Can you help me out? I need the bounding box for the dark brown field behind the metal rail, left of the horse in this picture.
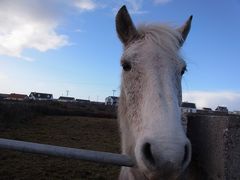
[0,116,120,180]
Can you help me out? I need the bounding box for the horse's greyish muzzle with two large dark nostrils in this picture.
[135,139,191,179]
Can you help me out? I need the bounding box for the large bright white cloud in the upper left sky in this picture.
[0,0,68,60]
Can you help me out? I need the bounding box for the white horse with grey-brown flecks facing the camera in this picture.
[116,6,192,180]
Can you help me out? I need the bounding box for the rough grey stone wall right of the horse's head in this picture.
[187,114,240,180]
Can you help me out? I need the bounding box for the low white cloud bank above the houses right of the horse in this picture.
[183,91,240,110]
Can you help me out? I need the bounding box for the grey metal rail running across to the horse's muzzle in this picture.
[0,138,134,167]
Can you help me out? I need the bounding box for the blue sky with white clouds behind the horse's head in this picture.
[0,0,240,110]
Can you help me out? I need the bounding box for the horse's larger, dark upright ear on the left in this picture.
[116,5,139,46]
